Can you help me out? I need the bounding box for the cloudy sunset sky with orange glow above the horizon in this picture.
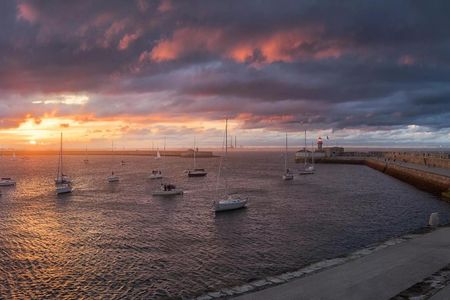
[0,0,450,149]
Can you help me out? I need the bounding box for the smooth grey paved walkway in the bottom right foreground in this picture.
[236,227,450,300]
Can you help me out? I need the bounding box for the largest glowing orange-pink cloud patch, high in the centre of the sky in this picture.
[146,28,342,63]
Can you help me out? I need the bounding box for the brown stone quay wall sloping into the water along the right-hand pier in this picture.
[317,158,450,197]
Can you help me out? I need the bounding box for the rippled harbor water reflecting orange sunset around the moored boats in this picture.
[0,152,450,299]
